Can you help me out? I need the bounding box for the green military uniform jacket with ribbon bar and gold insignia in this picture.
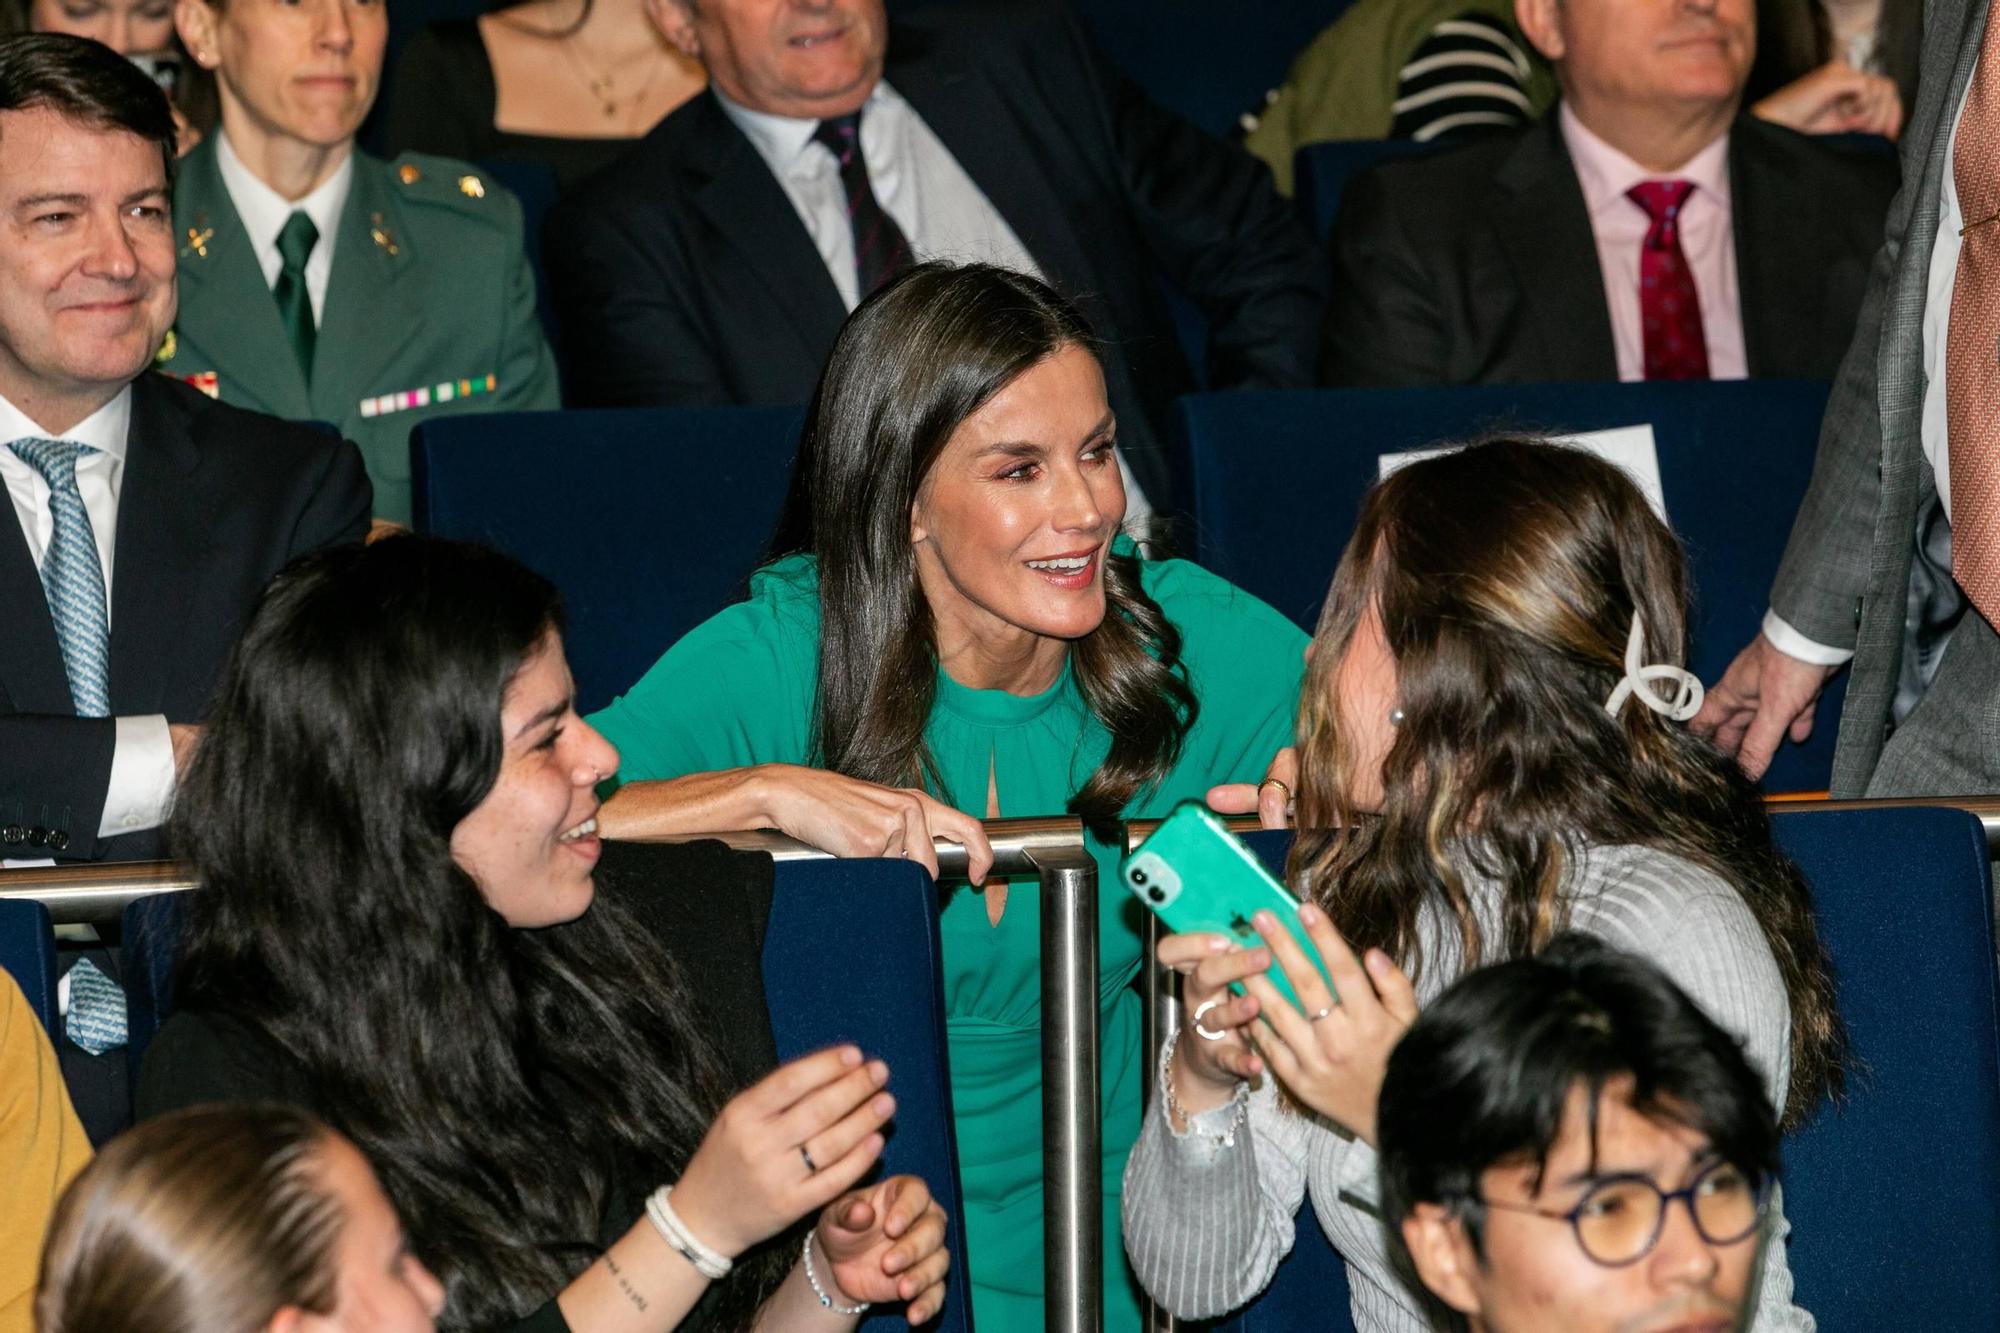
[158,138,560,522]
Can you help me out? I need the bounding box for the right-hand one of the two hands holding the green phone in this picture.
[1240,903,1416,1147]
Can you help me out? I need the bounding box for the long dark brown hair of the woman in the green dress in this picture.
[798,264,1198,831]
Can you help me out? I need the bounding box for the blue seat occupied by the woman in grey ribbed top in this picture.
[1222,809,2000,1333]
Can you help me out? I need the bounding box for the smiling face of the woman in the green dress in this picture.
[910,344,1126,656]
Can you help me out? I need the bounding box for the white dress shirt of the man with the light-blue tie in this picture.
[0,388,174,839]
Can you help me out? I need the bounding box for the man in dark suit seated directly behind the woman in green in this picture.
[544,0,1324,500]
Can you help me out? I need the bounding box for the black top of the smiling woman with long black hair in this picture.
[134,843,778,1333]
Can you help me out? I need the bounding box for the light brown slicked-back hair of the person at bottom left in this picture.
[34,1103,344,1333]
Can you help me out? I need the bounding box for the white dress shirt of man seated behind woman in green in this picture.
[714,80,1152,522]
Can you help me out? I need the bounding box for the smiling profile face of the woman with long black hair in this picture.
[452,634,618,927]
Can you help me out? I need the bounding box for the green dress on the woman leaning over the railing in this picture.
[590,556,1306,1333]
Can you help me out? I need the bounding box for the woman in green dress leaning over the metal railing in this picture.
[590,264,1306,1333]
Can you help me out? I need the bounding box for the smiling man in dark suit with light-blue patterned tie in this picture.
[0,36,370,861]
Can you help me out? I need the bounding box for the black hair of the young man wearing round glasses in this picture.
[1376,933,1778,1265]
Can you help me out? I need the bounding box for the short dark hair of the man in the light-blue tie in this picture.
[0,32,176,190]
